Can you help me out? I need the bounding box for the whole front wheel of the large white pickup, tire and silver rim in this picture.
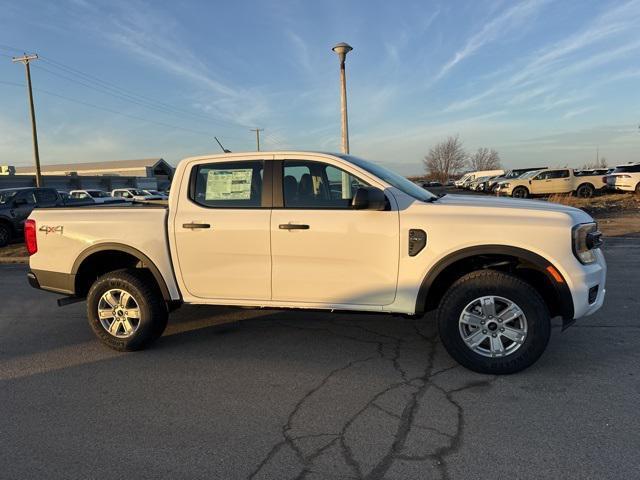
[437,270,551,374]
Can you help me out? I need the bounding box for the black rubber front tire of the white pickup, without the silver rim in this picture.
[437,270,551,375]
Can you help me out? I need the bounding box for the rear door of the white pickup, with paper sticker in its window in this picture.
[173,160,271,300]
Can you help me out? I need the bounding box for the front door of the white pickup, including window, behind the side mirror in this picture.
[271,160,399,305]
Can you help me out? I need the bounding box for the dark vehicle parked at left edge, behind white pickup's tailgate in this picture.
[0,187,63,247]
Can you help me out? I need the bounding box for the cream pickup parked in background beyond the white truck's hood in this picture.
[496,168,606,198]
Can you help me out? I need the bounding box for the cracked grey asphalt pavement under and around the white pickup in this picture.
[0,238,640,479]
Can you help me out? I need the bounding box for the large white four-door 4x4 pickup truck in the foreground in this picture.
[25,152,606,374]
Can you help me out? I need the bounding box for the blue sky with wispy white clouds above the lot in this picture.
[0,0,640,174]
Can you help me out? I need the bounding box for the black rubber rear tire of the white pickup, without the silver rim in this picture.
[87,269,168,352]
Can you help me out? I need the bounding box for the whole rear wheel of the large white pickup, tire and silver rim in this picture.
[87,269,168,352]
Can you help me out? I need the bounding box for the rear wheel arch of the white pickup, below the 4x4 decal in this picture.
[71,243,172,302]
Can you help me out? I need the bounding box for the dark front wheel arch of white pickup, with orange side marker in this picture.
[416,245,574,322]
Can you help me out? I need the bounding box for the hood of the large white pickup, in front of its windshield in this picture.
[437,195,593,223]
